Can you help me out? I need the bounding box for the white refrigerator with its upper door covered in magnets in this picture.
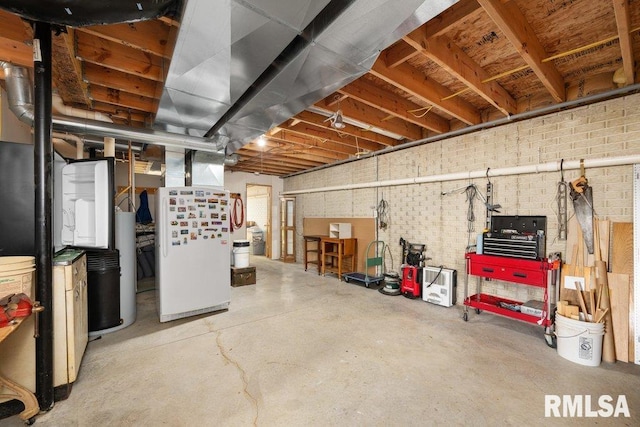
[155,187,231,322]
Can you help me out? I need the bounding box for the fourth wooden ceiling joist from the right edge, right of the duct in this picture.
[370,53,481,125]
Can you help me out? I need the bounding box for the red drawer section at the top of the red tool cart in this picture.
[467,254,549,287]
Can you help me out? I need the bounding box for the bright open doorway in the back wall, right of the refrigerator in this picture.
[247,184,272,258]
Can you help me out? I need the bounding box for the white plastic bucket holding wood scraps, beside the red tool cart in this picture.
[556,313,604,366]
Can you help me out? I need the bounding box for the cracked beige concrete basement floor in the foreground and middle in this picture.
[0,257,640,426]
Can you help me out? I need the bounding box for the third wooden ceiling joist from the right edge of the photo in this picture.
[403,27,517,116]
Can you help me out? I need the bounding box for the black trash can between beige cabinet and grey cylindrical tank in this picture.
[87,250,122,332]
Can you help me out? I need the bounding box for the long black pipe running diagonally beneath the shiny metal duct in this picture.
[204,0,356,138]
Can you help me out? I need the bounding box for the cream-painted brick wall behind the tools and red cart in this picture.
[284,95,640,304]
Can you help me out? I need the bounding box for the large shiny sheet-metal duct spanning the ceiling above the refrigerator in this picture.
[154,0,456,153]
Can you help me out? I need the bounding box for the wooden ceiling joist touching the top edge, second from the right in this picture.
[477,0,564,102]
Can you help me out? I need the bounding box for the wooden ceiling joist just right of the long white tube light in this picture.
[316,98,423,141]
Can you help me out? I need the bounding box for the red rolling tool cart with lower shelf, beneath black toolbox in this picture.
[462,253,560,347]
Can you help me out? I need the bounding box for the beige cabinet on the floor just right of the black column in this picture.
[53,250,89,391]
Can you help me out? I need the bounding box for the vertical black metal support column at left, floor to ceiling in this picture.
[33,22,53,411]
